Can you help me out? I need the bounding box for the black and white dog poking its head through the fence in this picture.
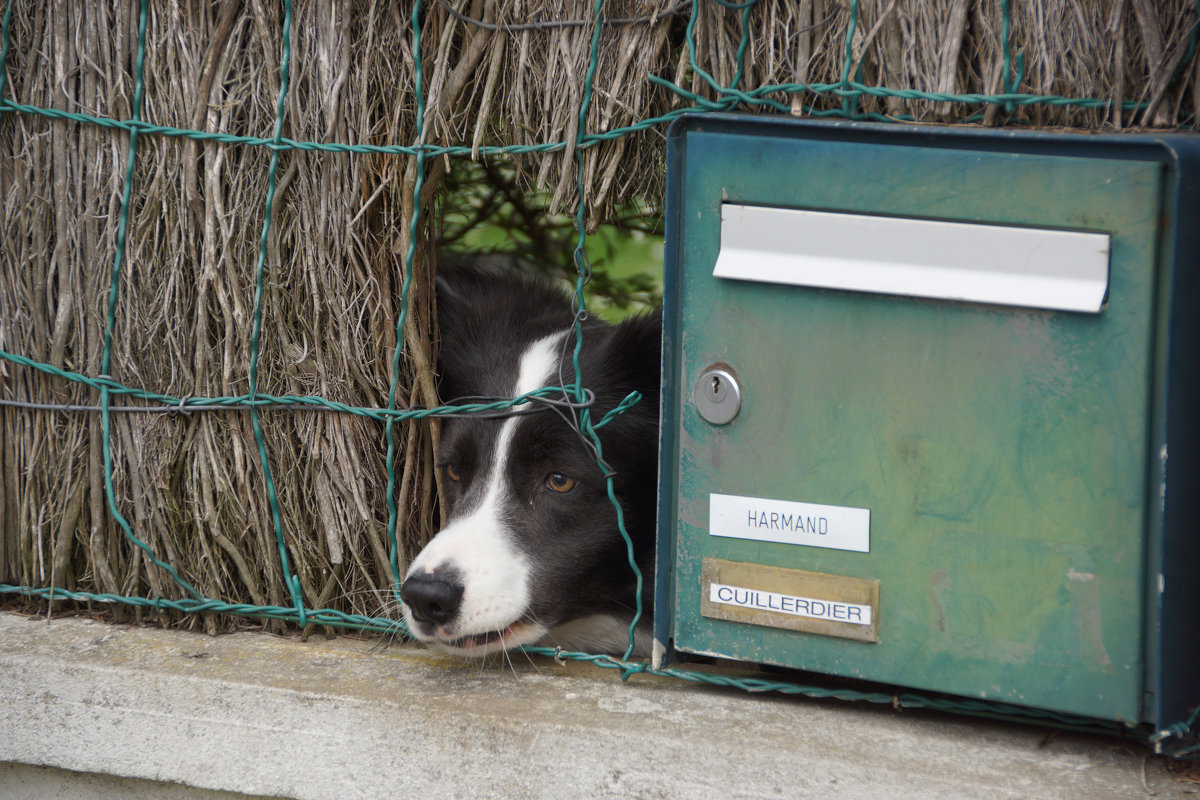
[401,270,662,656]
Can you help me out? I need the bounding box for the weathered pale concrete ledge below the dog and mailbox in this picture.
[0,614,1198,800]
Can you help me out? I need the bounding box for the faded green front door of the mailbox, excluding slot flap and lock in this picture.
[662,125,1162,722]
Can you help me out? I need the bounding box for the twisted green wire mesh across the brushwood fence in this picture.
[0,0,1200,756]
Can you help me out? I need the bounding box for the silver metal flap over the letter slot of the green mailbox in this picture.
[713,203,1111,314]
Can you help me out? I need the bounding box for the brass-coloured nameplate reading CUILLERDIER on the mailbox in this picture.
[700,558,880,642]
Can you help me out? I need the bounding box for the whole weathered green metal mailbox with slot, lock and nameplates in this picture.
[655,115,1200,726]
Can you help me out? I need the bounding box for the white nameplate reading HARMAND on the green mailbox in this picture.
[708,494,871,553]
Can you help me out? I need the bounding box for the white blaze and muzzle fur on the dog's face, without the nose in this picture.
[404,333,564,656]
